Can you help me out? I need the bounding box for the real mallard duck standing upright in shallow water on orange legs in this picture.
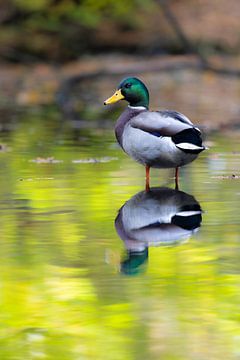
[104,77,205,190]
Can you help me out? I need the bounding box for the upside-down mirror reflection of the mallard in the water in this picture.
[115,187,202,275]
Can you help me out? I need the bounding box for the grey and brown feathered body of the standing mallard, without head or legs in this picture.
[115,107,204,168]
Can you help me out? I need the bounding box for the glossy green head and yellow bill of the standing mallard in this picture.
[104,77,149,109]
